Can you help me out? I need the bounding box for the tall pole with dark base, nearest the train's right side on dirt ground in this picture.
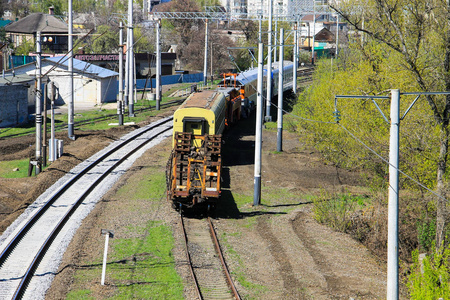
[253,42,264,206]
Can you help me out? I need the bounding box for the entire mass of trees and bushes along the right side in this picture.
[294,0,450,299]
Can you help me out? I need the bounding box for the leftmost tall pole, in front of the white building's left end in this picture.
[35,31,42,175]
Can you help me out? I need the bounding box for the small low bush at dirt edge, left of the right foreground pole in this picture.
[313,193,367,232]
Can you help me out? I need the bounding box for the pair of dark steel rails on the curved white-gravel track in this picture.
[0,117,173,299]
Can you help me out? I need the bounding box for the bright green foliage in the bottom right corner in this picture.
[408,247,450,300]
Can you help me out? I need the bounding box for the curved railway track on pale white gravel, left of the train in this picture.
[0,117,173,299]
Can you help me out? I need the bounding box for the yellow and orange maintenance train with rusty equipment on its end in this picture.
[166,62,293,209]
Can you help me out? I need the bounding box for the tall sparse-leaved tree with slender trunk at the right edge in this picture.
[333,0,450,249]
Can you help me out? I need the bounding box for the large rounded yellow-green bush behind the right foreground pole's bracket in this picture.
[293,43,439,188]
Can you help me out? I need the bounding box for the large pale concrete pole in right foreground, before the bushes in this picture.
[386,89,400,300]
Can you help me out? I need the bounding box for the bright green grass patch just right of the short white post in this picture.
[108,222,183,299]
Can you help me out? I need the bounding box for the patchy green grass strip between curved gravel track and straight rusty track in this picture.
[67,165,184,299]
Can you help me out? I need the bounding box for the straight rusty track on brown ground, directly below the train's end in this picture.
[180,215,241,300]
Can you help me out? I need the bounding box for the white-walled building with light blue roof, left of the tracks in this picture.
[6,56,119,105]
